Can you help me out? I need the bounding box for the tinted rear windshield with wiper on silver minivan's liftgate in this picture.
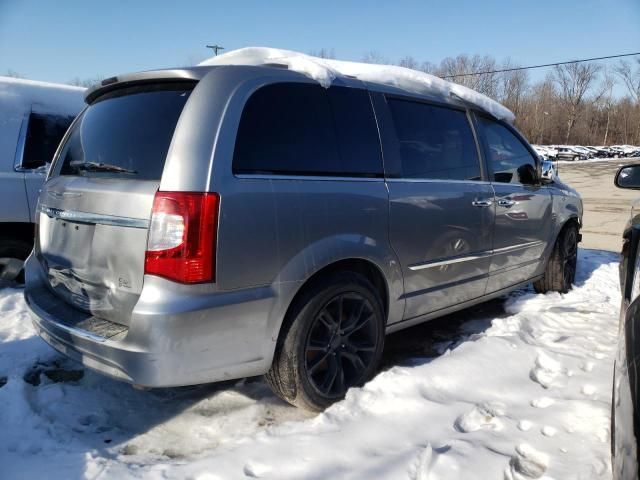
[59,82,194,180]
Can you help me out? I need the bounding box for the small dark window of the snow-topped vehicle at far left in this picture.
[22,113,74,168]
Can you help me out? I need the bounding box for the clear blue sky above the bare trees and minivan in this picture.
[0,0,640,93]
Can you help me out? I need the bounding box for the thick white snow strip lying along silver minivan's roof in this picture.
[199,47,515,122]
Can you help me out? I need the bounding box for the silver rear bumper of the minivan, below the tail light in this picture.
[24,256,279,387]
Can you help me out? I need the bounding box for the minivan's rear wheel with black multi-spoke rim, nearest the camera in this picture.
[265,272,385,411]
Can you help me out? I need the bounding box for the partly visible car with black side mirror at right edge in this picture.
[611,164,640,480]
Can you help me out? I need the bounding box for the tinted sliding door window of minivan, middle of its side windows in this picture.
[389,99,481,180]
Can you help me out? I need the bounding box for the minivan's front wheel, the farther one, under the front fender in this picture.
[533,223,578,293]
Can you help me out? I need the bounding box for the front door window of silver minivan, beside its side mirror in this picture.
[478,118,537,184]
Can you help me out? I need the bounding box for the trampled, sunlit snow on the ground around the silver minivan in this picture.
[0,250,619,480]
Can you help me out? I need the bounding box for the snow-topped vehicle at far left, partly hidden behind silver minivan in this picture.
[0,77,84,284]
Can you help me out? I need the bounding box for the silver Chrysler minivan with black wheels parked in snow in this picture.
[25,65,582,410]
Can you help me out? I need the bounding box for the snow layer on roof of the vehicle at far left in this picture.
[0,76,85,115]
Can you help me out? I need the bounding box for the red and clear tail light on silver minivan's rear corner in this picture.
[144,192,220,283]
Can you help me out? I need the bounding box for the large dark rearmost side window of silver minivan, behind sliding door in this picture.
[233,83,382,176]
